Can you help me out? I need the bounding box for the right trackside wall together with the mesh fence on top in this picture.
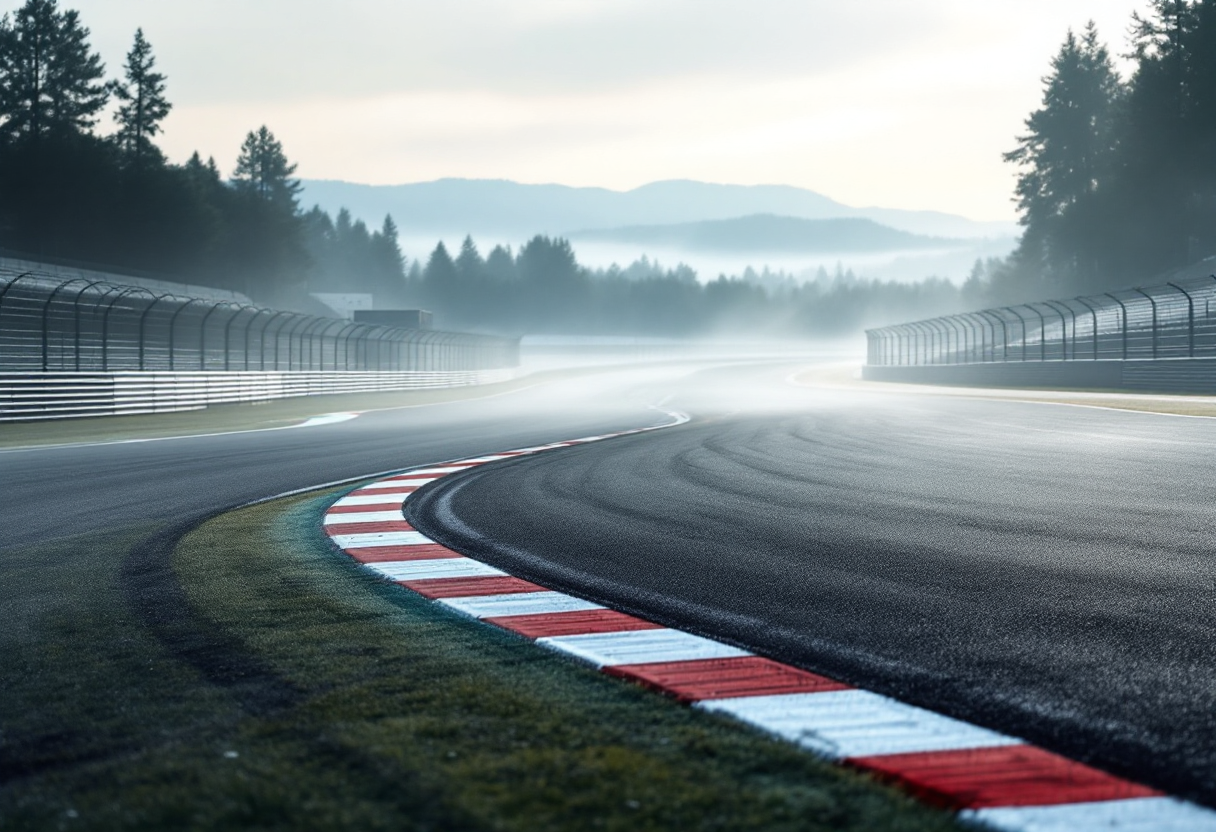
[863,275,1216,393]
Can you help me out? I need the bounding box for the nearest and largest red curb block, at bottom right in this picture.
[848,746,1162,809]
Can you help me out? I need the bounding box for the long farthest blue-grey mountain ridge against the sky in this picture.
[302,179,1018,240]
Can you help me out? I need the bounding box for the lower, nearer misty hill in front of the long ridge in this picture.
[570,214,958,254]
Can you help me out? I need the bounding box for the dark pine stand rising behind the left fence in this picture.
[0,0,405,307]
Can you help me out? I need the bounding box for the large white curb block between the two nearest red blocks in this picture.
[694,690,1021,759]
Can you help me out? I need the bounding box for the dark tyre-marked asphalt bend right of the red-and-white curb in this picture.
[409,367,1216,805]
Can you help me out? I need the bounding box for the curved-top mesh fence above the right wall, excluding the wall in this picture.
[866,275,1216,367]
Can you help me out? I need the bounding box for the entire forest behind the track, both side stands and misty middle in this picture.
[9,0,1216,337]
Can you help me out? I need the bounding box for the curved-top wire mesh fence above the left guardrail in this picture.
[0,269,519,373]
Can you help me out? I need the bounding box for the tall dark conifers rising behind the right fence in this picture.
[980,0,1216,303]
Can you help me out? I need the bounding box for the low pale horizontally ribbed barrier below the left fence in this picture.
[0,367,517,422]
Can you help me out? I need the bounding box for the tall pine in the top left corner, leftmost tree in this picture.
[0,0,108,141]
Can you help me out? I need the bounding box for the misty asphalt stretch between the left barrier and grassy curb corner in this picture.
[0,367,689,552]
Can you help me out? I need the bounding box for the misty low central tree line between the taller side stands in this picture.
[406,235,963,337]
